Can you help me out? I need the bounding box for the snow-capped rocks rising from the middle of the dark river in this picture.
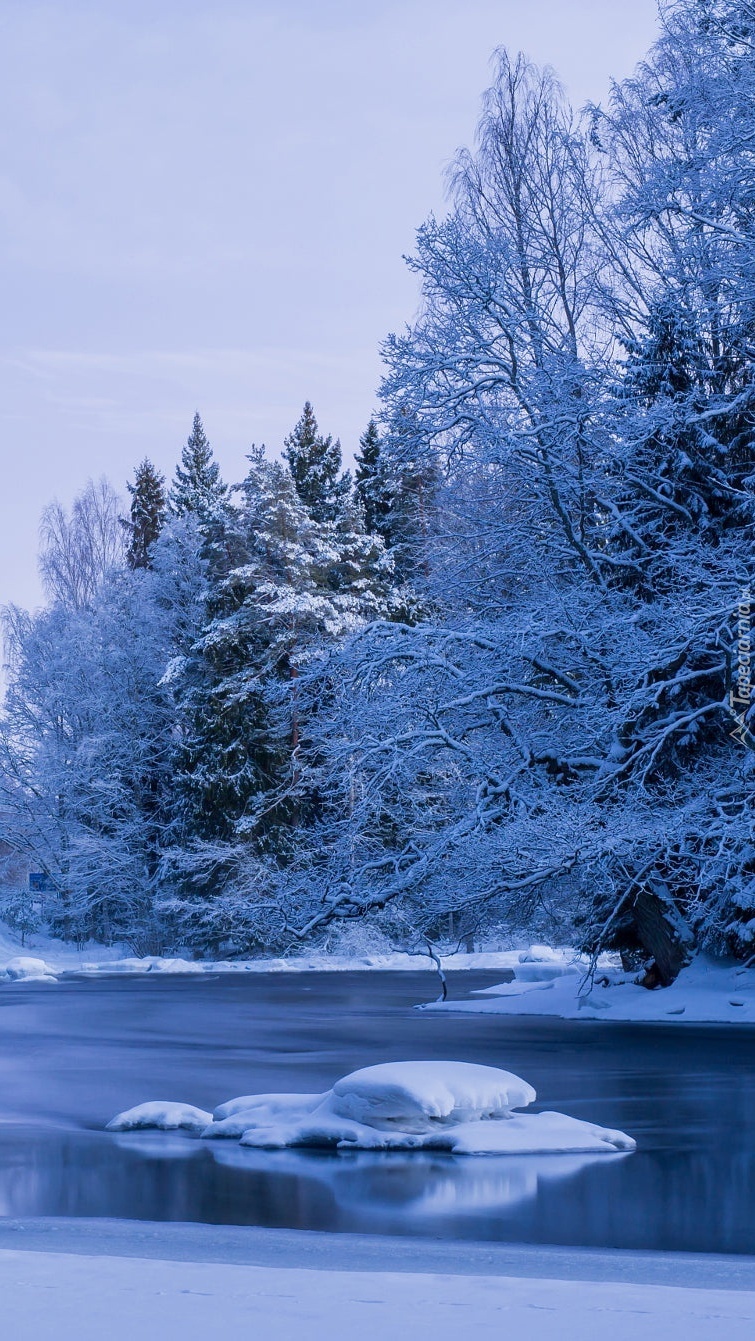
[107,1062,634,1155]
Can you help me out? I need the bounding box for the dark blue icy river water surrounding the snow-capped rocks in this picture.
[0,972,755,1252]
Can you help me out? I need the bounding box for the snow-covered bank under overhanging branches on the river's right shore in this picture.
[421,955,755,1025]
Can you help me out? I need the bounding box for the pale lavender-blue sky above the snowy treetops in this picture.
[0,0,656,603]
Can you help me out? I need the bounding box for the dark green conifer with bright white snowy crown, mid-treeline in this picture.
[172,449,390,852]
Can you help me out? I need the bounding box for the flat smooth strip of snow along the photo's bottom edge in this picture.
[0,1250,755,1341]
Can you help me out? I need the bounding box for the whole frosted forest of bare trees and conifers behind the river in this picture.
[0,0,755,986]
